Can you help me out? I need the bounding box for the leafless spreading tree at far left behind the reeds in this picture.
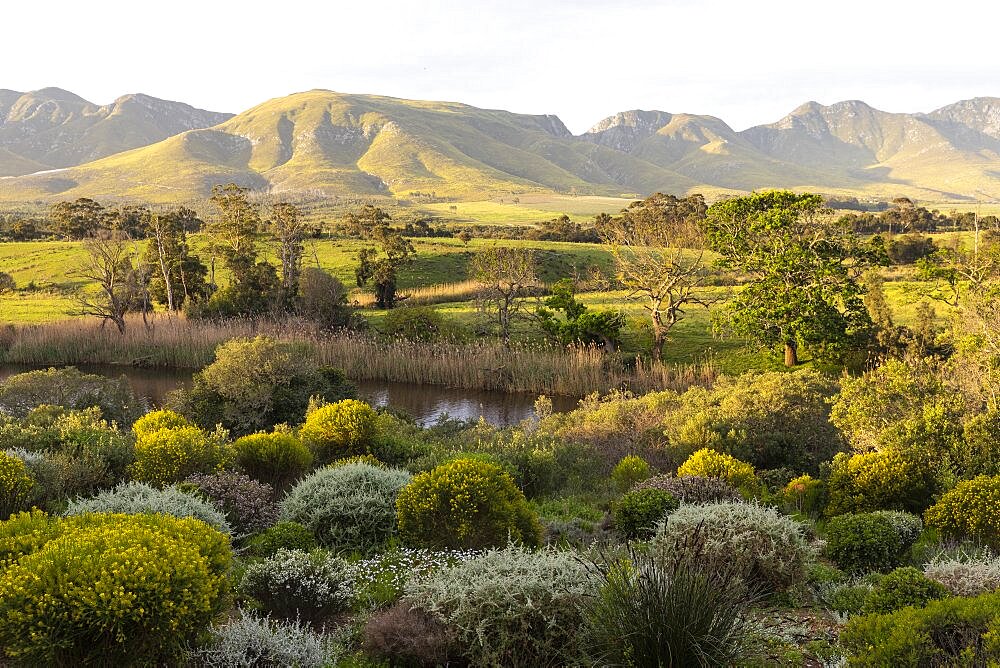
[73,231,142,334]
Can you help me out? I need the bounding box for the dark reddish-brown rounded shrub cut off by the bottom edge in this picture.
[362,603,461,666]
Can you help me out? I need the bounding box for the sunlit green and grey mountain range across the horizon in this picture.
[0,88,1000,202]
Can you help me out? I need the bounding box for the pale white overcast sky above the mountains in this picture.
[0,0,1000,133]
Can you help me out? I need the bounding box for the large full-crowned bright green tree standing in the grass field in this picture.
[705,191,884,366]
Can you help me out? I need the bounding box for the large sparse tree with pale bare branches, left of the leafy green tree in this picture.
[595,193,709,359]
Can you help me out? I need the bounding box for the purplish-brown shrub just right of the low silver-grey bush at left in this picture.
[185,471,278,535]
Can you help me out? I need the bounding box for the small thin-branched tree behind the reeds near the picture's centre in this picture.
[472,246,539,343]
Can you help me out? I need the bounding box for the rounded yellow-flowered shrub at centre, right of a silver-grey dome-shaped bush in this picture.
[396,459,541,549]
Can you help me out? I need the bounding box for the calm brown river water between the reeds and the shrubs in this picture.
[0,364,576,427]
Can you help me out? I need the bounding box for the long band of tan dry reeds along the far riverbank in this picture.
[0,317,717,396]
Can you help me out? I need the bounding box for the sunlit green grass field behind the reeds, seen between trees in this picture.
[0,228,968,373]
